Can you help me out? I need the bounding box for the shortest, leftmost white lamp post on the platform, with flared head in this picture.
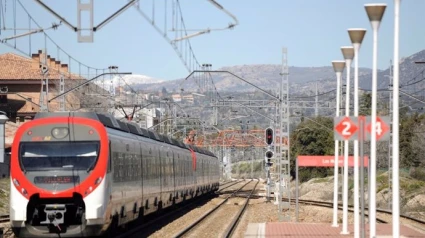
[332,60,345,227]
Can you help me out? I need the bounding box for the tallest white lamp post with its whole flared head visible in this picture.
[365,3,387,237]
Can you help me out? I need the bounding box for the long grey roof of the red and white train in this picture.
[34,112,215,157]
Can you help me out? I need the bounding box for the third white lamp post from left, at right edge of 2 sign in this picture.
[348,28,366,237]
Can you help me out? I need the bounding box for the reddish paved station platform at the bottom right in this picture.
[245,222,425,238]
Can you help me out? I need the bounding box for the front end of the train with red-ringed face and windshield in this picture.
[10,113,110,237]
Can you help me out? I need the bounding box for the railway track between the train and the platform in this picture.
[174,181,258,237]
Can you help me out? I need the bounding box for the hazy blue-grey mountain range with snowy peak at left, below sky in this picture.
[119,50,425,95]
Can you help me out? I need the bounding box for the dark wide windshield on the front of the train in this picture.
[19,141,100,172]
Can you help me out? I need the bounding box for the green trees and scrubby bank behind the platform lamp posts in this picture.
[290,93,425,212]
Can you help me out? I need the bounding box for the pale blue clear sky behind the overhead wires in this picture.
[0,0,425,80]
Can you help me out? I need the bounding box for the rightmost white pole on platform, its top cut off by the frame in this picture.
[392,0,401,237]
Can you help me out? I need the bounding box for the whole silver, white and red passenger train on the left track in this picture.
[10,112,219,237]
